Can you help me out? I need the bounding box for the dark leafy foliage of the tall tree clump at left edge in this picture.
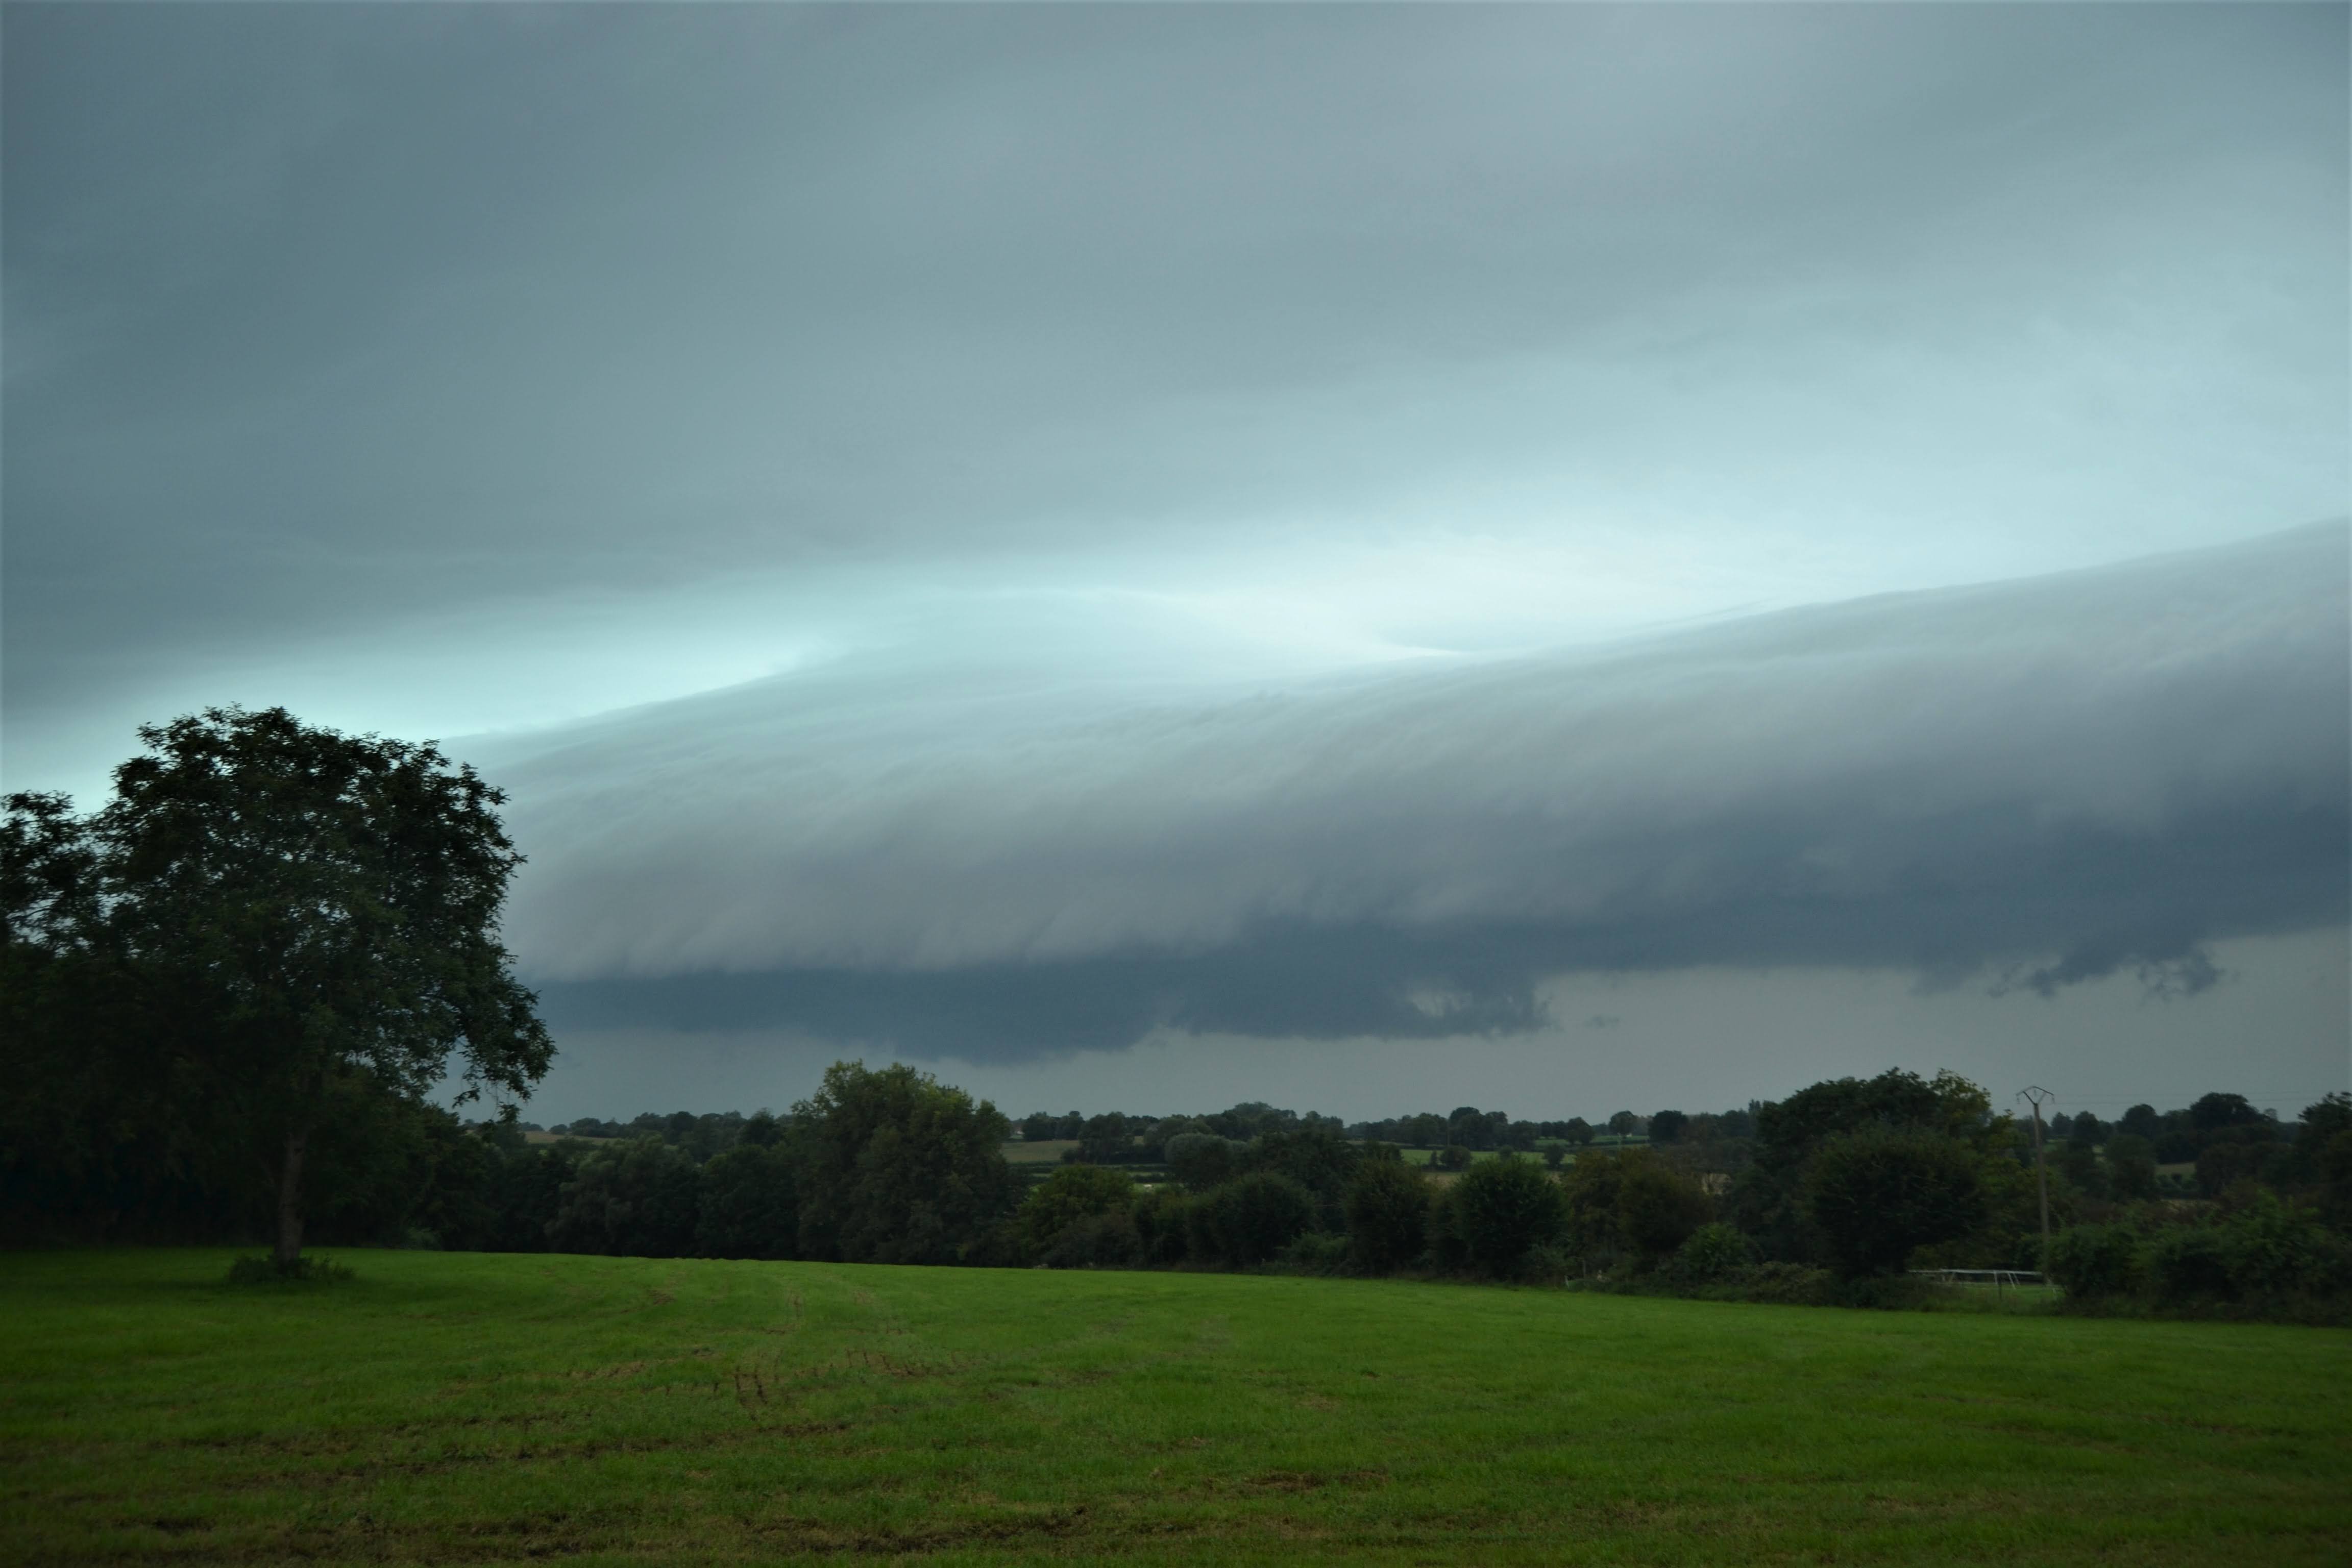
[0,707,553,1267]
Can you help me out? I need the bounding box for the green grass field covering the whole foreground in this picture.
[0,1251,2352,1565]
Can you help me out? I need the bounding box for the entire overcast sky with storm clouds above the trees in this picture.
[0,3,2352,1121]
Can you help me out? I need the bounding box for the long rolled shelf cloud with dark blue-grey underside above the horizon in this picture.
[515,524,2352,1058]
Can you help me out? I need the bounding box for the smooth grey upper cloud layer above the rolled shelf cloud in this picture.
[5,7,2345,724]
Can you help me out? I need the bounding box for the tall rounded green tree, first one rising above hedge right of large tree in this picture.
[793,1063,1018,1262]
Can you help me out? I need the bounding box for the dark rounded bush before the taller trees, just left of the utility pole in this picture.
[1806,1129,1985,1279]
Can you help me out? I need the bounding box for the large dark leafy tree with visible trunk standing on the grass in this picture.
[92,707,555,1269]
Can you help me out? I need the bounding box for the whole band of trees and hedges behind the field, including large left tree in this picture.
[0,710,2352,1305]
